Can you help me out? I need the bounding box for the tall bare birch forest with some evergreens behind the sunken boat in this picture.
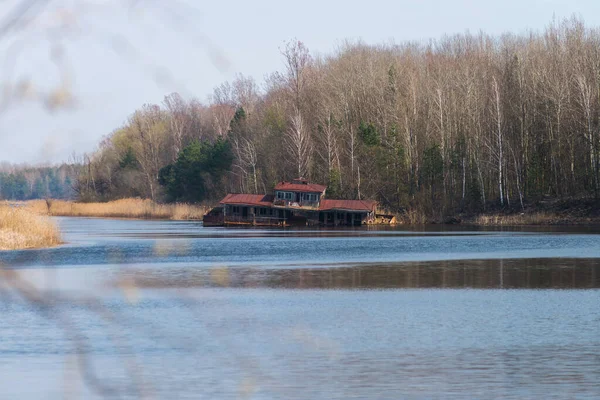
[79,19,600,216]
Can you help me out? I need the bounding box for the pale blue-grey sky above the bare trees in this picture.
[0,0,600,164]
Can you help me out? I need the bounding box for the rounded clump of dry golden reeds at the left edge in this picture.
[0,203,61,250]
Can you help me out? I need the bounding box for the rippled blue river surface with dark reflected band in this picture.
[0,218,600,400]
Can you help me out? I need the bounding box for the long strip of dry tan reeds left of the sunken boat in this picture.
[28,199,209,220]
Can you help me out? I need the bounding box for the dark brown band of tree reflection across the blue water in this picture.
[124,259,600,289]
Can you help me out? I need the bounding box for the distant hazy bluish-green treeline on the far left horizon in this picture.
[0,164,79,200]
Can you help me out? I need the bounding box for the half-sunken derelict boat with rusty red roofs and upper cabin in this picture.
[214,178,377,226]
